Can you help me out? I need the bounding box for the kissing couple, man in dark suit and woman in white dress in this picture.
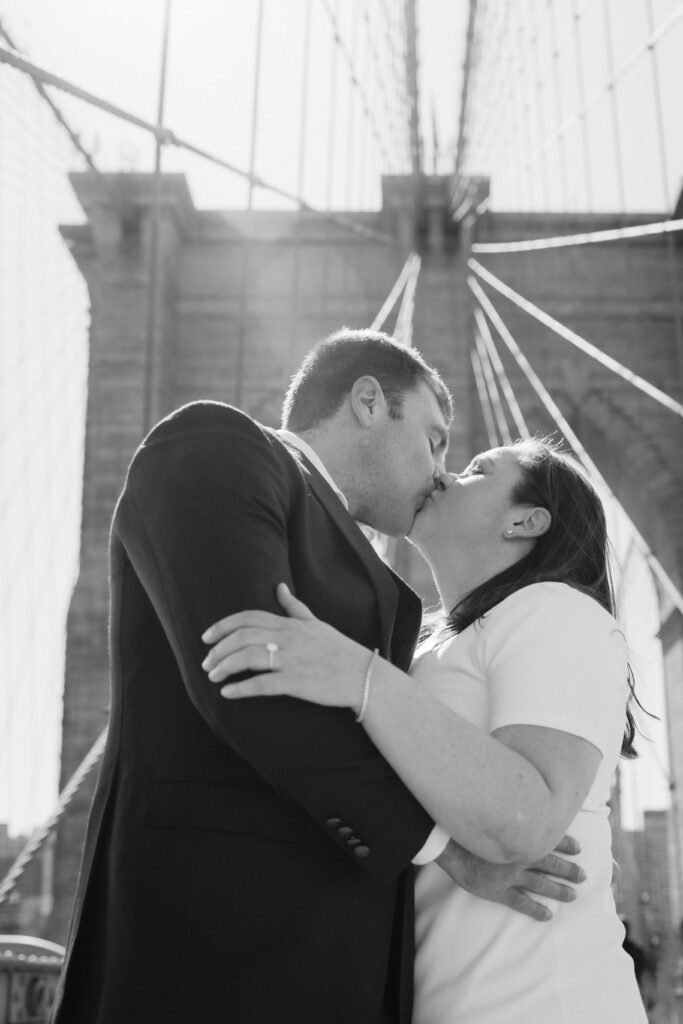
[52,330,646,1024]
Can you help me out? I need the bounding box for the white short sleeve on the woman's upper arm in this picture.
[477,583,628,757]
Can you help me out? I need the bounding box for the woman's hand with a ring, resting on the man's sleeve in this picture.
[202,583,370,711]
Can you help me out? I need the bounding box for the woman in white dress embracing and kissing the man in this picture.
[205,440,646,1024]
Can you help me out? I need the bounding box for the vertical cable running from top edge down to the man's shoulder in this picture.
[142,0,172,433]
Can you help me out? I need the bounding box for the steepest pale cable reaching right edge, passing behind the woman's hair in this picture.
[467,278,683,613]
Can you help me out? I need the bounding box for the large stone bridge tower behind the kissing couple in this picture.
[50,174,683,940]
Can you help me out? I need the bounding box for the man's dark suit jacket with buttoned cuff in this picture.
[53,403,432,1024]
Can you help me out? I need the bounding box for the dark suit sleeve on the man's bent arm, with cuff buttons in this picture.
[114,411,432,882]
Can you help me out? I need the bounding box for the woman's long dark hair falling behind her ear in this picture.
[437,438,637,758]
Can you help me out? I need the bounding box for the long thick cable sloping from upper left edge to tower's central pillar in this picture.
[0,46,402,249]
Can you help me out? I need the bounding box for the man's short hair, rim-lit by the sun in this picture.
[283,328,453,432]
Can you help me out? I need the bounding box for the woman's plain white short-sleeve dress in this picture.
[413,583,647,1024]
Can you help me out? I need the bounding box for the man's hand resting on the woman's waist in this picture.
[436,836,586,921]
